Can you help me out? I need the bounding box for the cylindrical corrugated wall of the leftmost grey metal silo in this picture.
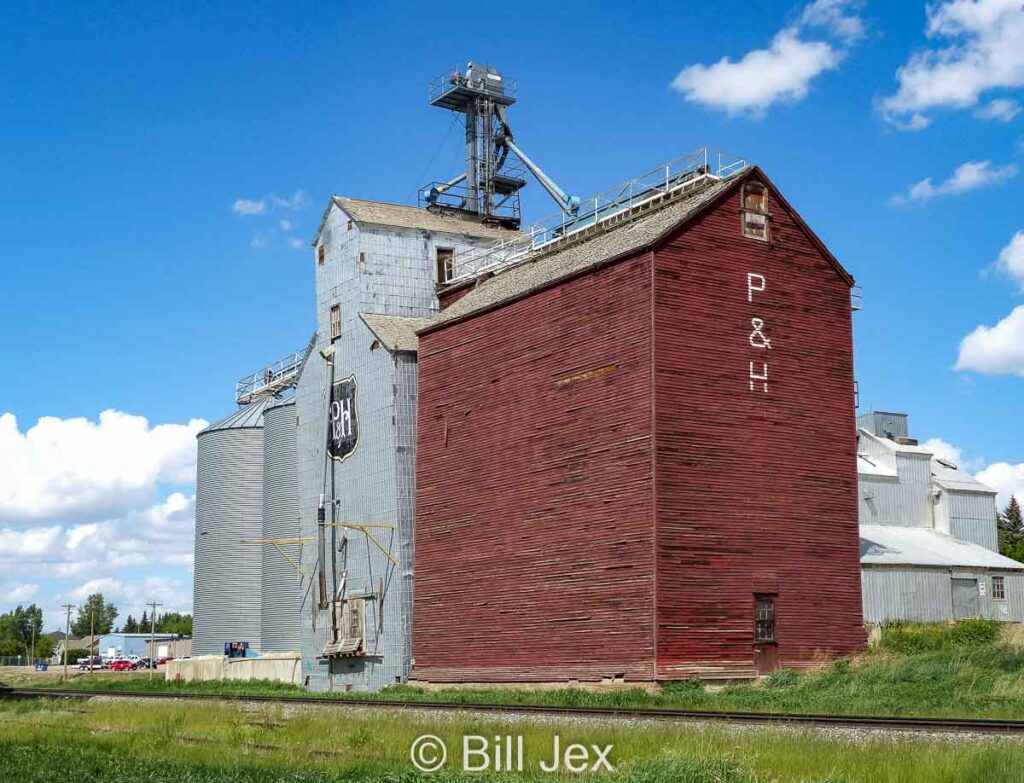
[193,427,263,655]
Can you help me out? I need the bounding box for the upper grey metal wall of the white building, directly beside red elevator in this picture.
[859,454,933,527]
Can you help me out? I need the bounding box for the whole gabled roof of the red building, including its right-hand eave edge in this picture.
[420,167,853,334]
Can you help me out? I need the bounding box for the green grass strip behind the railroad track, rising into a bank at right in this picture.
[19,620,1024,719]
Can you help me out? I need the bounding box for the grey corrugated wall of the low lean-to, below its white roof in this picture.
[861,566,1024,623]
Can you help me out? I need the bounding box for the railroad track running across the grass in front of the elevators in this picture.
[0,688,1024,735]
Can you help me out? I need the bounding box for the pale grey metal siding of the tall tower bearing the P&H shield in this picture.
[296,202,493,691]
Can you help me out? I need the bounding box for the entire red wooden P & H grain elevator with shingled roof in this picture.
[413,161,864,682]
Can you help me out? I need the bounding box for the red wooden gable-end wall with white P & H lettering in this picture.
[654,189,864,679]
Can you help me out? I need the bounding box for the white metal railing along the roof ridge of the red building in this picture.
[450,146,746,284]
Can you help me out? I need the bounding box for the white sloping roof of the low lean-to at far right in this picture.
[860,525,1024,571]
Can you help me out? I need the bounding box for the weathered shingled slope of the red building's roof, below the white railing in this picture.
[420,169,750,334]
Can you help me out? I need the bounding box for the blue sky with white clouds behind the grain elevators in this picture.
[0,0,1024,625]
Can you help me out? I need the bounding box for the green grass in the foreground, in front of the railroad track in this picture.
[0,699,1024,783]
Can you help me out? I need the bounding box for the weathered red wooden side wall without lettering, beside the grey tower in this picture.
[413,255,654,682]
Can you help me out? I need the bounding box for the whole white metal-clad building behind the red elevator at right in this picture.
[857,411,1024,622]
